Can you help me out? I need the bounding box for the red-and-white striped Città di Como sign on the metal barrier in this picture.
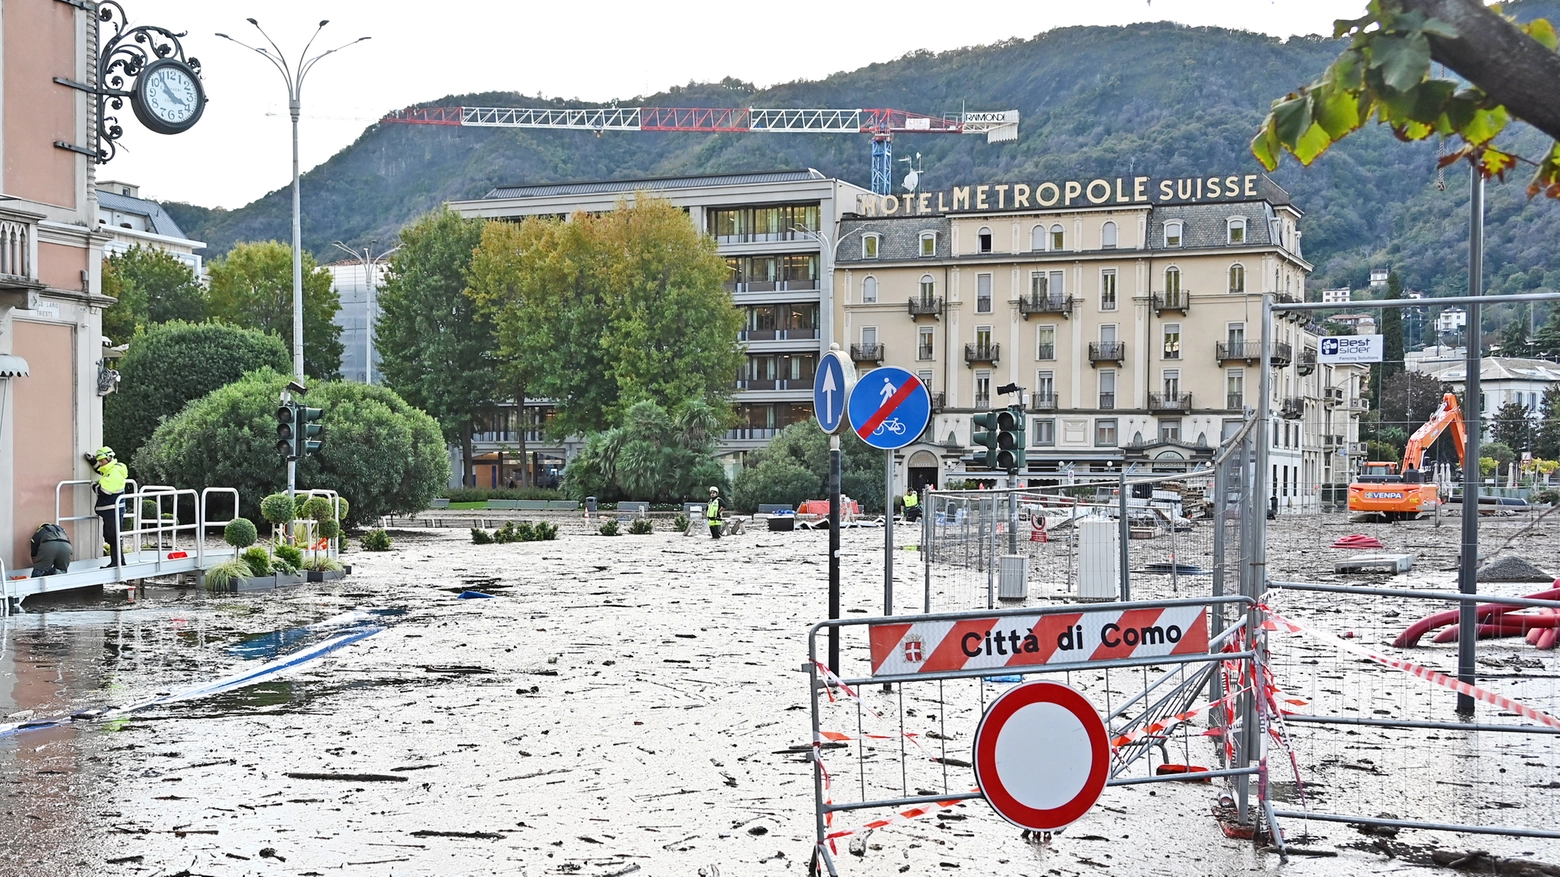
[869,605,1207,676]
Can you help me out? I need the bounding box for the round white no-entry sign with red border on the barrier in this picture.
[975,682,1111,832]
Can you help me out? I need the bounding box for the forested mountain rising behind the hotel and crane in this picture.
[168,0,1560,307]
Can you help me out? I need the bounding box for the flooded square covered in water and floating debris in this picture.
[0,517,1560,877]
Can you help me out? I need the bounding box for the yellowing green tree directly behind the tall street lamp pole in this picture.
[207,240,345,381]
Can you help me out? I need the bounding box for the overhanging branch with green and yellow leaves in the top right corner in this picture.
[1251,0,1560,198]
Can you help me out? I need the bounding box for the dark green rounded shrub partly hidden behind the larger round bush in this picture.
[103,321,292,460]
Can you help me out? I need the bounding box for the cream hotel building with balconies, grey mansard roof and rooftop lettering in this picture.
[833,175,1365,510]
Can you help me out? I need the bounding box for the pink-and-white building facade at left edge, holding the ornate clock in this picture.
[0,0,112,573]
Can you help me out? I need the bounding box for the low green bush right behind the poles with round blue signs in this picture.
[732,421,883,513]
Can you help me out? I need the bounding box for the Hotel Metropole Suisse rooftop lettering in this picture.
[856,173,1265,217]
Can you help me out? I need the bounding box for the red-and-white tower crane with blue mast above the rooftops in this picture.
[381,106,1019,195]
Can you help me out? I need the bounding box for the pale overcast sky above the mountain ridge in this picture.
[98,0,1365,208]
